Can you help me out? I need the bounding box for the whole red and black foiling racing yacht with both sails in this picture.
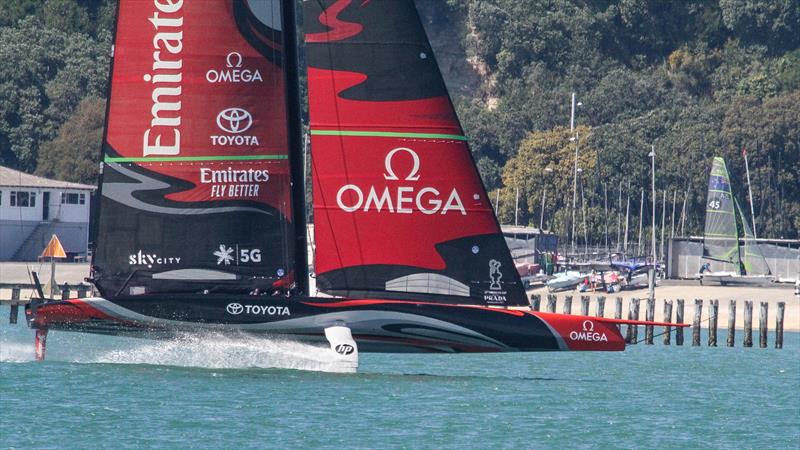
[26,0,676,370]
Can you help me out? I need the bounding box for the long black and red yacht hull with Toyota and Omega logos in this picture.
[26,294,625,353]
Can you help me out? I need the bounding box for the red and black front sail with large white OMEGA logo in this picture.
[305,0,527,305]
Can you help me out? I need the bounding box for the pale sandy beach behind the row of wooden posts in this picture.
[528,281,800,331]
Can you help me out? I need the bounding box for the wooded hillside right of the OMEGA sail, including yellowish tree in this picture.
[450,0,800,242]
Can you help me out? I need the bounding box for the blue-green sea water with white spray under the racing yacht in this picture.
[0,306,800,449]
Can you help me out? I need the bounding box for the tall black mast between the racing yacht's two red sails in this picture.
[283,1,308,295]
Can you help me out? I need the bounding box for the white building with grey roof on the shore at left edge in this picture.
[0,166,95,261]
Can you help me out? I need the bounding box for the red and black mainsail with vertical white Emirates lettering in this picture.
[92,0,296,298]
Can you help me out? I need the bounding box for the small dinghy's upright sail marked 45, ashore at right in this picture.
[703,157,741,272]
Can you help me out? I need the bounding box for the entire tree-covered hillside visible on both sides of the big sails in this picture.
[0,0,800,242]
